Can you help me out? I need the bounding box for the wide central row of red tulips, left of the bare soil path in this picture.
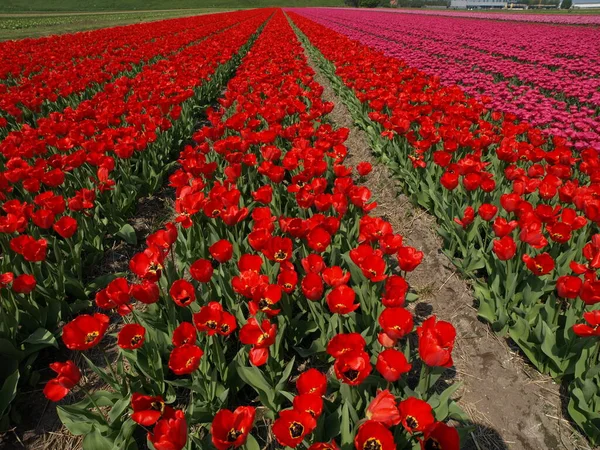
[44,11,464,450]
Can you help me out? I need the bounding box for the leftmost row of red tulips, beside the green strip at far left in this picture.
[0,14,248,135]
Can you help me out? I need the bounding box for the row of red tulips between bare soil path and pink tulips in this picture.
[292,9,600,441]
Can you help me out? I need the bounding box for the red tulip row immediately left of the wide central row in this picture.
[0,11,270,427]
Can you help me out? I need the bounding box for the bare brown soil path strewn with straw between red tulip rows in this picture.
[302,37,589,450]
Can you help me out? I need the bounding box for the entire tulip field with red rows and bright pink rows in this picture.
[0,8,600,450]
